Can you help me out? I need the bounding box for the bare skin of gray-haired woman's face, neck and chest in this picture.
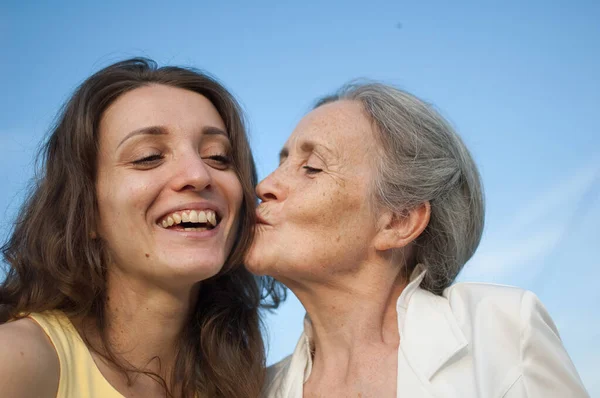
[246,101,408,398]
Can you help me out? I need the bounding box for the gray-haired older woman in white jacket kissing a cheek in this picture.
[247,84,587,398]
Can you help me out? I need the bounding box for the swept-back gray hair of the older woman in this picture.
[315,82,484,294]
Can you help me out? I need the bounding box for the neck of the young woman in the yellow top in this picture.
[86,271,198,381]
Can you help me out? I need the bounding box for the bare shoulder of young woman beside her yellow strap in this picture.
[0,318,60,397]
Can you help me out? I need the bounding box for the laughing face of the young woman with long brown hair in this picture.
[96,84,243,285]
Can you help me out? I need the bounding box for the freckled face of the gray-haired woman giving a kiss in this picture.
[246,101,377,282]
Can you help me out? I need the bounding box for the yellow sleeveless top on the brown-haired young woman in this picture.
[29,311,124,398]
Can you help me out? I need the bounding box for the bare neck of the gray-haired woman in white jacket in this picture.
[290,262,407,371]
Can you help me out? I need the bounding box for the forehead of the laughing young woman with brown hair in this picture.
[100,84,225,139]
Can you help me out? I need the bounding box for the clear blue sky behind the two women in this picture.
[0,0,600,396]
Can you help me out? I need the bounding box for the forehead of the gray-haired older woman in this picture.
[285,100,375,157]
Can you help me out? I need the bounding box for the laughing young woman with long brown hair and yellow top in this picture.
[0,59,276,398]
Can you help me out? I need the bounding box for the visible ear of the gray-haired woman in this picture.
[374,202,431,251]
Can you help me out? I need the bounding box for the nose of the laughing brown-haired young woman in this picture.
[172,153,212,191]
